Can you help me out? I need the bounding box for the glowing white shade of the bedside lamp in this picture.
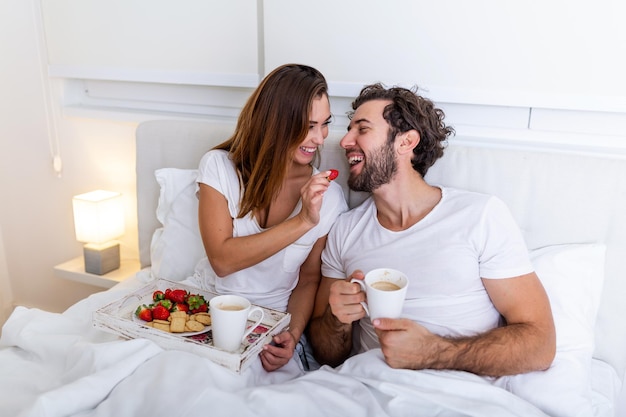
[72,190,124,244]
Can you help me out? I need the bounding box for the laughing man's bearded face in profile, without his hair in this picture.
[341,100,397,192]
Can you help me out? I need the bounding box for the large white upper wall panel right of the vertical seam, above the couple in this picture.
[265,0,626,111]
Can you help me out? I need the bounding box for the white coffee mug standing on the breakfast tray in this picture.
[209,295,265,352]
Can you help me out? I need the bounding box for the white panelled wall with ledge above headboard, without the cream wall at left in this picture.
[42,0,626,153]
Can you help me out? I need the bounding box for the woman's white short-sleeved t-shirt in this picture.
[191,150,348,311]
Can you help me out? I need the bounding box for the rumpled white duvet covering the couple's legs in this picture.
[0,276,546,417]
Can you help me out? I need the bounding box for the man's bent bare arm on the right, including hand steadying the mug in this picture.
[373,273,556,376]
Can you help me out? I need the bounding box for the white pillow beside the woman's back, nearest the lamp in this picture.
[150,168,205,281]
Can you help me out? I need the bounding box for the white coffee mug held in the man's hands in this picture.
[350,268,409,320]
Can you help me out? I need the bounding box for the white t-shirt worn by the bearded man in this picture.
[322,187,533,351]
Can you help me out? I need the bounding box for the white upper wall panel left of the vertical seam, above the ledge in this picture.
[42,0,258,86]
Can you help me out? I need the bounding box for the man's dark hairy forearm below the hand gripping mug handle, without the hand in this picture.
[309,306,352,367]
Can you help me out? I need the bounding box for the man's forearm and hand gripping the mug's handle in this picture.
[308,277,365,366]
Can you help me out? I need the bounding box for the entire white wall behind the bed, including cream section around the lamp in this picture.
[0,0,626,328]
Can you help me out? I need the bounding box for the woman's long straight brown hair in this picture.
[214,64,328,218]
